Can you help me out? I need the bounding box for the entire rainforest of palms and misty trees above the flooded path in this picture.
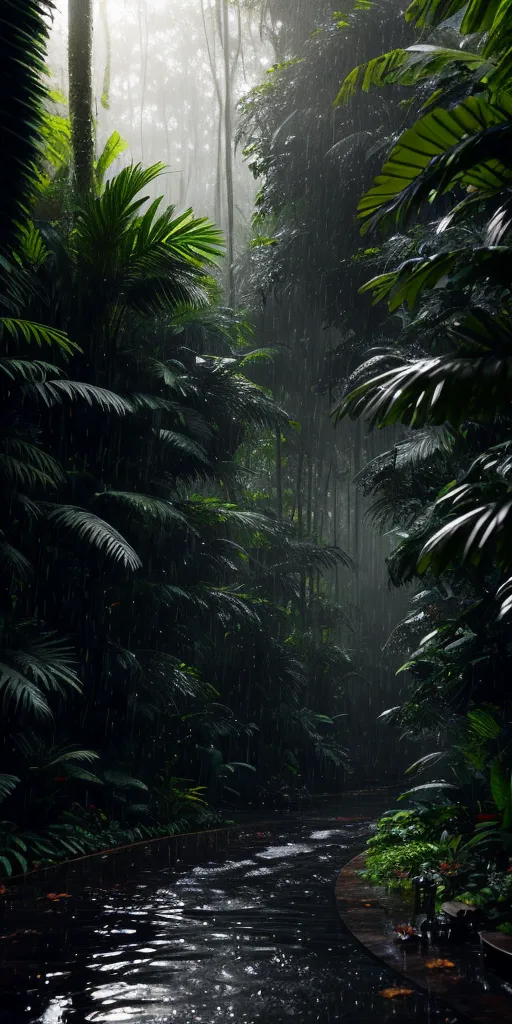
[4,0,512,1007]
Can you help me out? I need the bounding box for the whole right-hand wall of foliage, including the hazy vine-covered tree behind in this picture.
[240,0,512,932]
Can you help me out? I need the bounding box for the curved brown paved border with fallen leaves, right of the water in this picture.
[336,854,512,1024]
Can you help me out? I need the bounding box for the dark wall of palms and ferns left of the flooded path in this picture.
[0,0,350,873]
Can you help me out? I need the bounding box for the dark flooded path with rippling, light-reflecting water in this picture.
[0,801,461,1024]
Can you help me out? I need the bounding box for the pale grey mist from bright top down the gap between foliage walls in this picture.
[44,0,408,771]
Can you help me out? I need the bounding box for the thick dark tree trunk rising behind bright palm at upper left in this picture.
[68,0,94,200]
